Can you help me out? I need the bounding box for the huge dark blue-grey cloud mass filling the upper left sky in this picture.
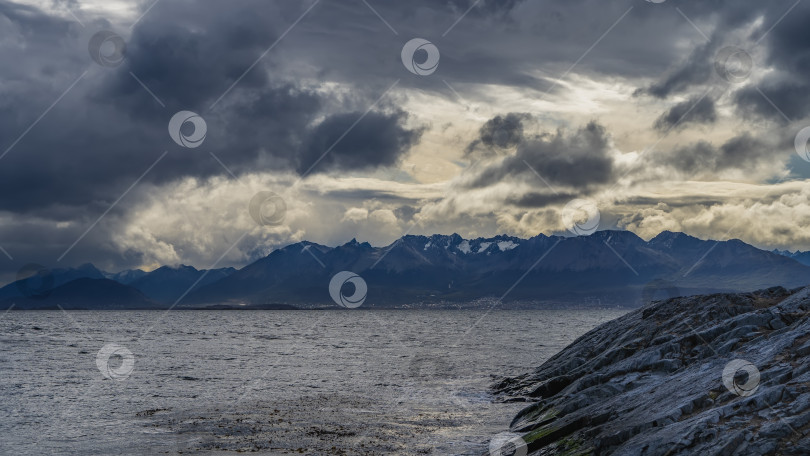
[0,1,430,216]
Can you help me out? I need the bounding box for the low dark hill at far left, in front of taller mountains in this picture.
[3,278,159,310]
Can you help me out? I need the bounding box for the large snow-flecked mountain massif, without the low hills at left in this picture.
[186,231,810,306]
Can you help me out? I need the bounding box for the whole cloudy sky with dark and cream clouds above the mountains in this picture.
[0,0,810,278]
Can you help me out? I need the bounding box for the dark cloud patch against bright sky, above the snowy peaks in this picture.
[468,122,613,189]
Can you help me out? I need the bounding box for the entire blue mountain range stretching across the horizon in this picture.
[0,231,810,309]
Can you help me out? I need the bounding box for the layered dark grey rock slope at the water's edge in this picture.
[489,287,810,456]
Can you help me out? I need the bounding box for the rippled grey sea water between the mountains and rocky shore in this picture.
[0,310,624,455]
